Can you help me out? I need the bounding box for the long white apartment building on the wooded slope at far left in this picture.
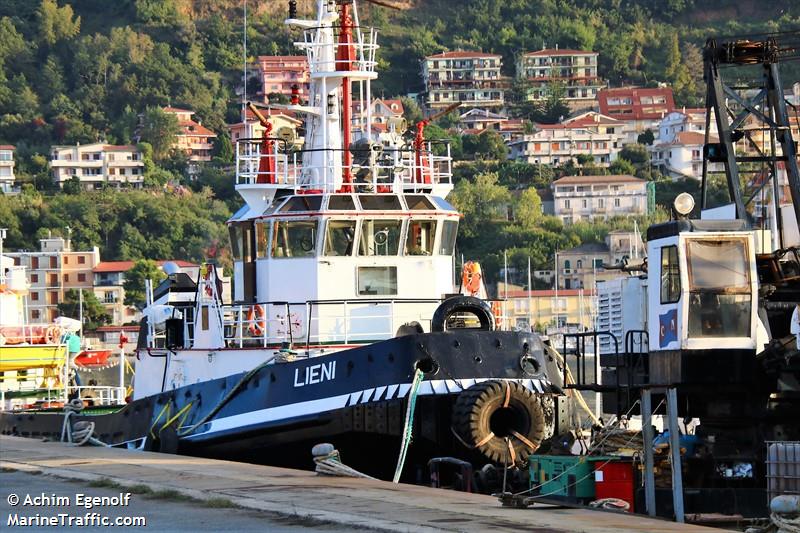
[50,143,144,189]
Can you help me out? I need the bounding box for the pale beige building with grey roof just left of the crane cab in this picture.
[556,230,647,289]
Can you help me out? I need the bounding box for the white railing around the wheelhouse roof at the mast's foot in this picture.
[236,139,453,194]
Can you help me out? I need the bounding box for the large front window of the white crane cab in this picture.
[686,239,752,337]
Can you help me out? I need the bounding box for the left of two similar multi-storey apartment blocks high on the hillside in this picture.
[422,51,510,109]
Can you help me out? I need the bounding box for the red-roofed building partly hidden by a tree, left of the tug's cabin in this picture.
[92,260,200,326]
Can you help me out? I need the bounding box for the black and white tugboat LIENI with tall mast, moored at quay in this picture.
[0,0,562,481]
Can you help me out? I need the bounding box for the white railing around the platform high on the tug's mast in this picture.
[294,26,378,78]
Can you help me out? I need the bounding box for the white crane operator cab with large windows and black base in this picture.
[647,203,767,385]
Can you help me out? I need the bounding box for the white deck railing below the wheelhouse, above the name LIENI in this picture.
[216,299,441,349]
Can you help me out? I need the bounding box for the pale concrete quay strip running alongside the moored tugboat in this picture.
[0,436,719,533]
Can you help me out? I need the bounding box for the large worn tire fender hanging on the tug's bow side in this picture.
[453,380,545,465]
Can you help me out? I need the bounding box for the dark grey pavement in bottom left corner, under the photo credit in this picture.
[0,470,352,533]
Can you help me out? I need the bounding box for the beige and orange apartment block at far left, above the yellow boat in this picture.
[5,237,100,324]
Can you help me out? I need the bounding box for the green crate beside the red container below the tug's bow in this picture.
[528,455,610,499]
